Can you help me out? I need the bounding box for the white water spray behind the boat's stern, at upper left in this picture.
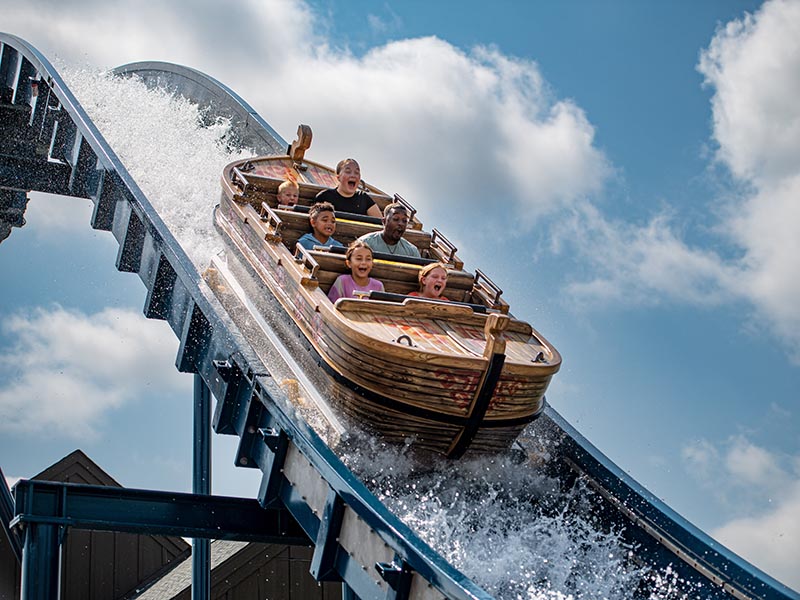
[61,66,252,270]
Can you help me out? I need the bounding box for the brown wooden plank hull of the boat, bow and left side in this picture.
[215,159,560,456]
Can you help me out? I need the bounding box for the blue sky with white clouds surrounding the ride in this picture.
[0,0,800,589]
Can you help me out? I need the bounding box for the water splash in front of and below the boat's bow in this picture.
[343,424,664,599]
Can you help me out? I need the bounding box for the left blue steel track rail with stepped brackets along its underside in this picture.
[0,33,491,600]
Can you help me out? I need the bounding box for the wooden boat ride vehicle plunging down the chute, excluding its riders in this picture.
[215,126,561,458]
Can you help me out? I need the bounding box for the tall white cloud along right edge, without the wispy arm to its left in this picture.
[699,0,800,361]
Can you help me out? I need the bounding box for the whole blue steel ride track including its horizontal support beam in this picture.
[0,33,800,600]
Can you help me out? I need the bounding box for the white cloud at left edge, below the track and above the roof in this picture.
[0,306,190,440]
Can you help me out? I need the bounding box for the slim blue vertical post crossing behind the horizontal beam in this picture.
[192,374,211,600]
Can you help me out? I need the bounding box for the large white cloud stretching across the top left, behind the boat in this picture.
[4,0,610,237]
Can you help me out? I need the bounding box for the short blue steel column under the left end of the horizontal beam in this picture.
[20,523,61,600]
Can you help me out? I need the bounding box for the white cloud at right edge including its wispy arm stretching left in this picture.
[554,0,800,362]
